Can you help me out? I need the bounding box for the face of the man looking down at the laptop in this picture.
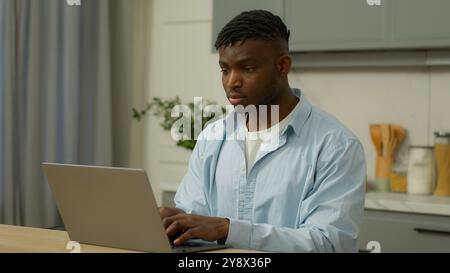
[219,40,281,107]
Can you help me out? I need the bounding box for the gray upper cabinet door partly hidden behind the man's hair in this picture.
[212,0,284,51]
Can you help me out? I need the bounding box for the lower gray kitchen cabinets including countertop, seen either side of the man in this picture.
[162,188,450,253]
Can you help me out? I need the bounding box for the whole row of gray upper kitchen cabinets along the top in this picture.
[212,0,450,53]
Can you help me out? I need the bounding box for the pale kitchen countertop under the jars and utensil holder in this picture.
[365,192,450,216]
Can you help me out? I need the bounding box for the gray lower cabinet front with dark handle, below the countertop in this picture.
[358,209,450,252]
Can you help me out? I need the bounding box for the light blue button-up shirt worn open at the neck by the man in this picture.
[175,89,366,252]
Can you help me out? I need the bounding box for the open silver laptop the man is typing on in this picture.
[42,163,226,253]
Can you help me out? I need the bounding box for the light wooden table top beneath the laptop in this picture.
[0,225,256,253]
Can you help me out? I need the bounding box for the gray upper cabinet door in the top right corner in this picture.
[390,0,450,48]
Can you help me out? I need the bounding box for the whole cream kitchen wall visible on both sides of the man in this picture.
[145,0,450,204]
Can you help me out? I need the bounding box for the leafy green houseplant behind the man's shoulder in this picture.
[133,96,226,150]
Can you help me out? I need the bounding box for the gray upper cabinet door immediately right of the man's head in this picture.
[285,0,390,51]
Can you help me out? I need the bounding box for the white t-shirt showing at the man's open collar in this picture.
[245,102,300,174]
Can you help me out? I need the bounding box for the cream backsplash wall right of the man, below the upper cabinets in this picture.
[290,67,450,179]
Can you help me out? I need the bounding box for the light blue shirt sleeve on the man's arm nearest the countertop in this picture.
[226,139,366,252]
